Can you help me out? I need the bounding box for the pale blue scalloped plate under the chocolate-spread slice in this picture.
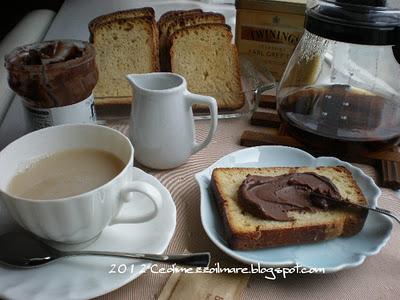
[196,146,392,273]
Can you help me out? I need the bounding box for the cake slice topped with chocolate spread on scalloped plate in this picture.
[211,167,367,250]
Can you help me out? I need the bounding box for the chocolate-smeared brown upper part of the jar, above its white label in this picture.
[5,40,98,108]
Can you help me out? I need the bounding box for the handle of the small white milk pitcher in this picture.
[185,91,218,154]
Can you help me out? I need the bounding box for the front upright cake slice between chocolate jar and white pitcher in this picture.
[92,16,159,105]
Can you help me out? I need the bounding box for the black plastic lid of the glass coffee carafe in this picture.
[305,0,400,45]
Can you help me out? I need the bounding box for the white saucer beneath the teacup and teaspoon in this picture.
[0,168,176,300]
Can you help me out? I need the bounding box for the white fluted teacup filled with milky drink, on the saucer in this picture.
[0,124,163,244]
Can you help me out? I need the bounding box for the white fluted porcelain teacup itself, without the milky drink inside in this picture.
[0,124,162,244]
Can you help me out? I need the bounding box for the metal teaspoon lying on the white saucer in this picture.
[0,232,210,268]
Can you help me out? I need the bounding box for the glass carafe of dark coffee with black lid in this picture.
[277,0,400,153]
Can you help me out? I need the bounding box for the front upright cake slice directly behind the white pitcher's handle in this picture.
[169,24,244,111]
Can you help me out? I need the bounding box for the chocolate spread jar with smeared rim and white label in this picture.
[5,40,98,129]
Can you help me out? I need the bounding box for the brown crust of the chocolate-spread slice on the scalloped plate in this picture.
[210,167,367,250]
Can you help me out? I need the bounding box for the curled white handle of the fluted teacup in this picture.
[110,181,162,225]
